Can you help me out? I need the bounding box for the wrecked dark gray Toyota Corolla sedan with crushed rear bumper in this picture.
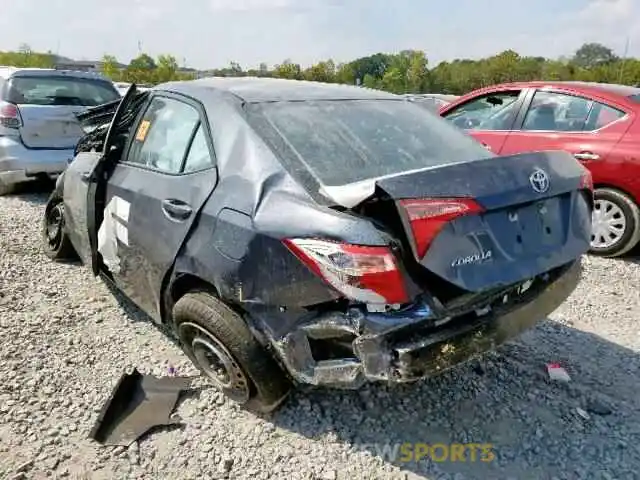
[42,78,593,411]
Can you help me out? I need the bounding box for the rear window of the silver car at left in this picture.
[2,75,120,107]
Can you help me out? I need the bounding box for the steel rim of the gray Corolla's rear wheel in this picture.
[179,322,251,403]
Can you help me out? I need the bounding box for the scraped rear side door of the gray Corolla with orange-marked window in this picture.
[98,93,218,321]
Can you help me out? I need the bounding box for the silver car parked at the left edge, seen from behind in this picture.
[0,67,120,195]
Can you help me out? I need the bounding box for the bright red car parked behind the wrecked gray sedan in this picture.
[439,82,640,257]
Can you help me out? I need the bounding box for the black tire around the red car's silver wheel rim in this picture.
[589,188,640,258]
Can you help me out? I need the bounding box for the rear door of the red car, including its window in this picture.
[502,89,631,166]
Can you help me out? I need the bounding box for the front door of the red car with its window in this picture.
[441,89,527,154]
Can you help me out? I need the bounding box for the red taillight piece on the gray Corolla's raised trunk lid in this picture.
[400,198,484,258]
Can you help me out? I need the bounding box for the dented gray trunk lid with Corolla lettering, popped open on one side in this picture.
[328,151,591,292]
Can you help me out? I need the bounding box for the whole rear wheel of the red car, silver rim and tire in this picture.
[590,188,640,257]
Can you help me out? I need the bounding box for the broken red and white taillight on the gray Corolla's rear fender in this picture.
[284,238,408,304]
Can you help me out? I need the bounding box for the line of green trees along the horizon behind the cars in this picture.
[0,43,640,94]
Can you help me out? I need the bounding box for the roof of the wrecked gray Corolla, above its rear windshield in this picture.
[155,77,402,103]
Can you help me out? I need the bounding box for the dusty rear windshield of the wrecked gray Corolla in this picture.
[248,100,492,186]
